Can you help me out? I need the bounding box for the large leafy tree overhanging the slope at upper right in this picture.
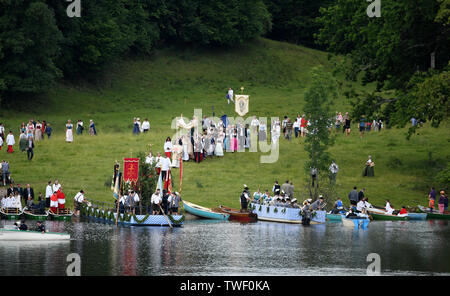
[317,0,450,133]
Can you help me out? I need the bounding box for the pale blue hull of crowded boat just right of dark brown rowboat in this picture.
[251,203,326,224]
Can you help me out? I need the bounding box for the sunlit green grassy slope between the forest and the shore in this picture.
[0,39,449,207]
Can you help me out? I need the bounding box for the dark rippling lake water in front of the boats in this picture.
[0,220,450,276]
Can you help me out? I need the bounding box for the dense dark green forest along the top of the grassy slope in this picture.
[0,0,450,134]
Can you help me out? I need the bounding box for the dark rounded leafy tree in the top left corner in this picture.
[0,0,61,94]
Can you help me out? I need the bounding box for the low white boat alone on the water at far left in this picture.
[0,228,70,241]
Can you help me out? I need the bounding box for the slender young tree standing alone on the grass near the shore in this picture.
[304,67,337,198]
